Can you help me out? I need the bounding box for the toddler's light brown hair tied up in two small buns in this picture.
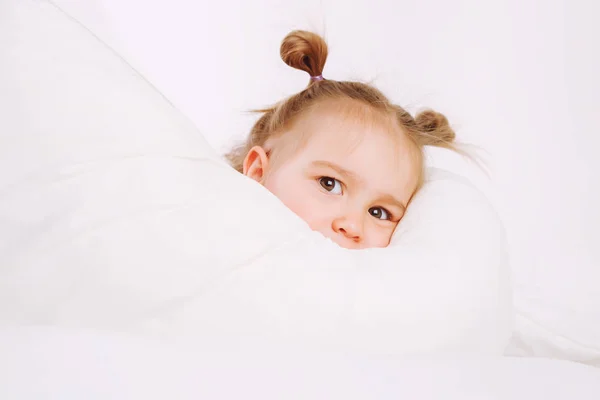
[225,31,460,182]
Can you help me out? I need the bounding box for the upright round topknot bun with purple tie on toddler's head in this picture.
[280,31,327,77]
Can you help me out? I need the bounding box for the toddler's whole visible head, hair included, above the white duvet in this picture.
[227,31,455,249]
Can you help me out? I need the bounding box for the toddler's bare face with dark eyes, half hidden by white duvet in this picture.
[246,101,420,249]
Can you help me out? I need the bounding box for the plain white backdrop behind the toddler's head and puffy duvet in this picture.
[55,0,600,304]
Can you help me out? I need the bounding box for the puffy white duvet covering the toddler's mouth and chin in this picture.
[0,0,511,354]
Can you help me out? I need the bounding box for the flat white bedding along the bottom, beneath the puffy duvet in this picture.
[0,328,600,400]
